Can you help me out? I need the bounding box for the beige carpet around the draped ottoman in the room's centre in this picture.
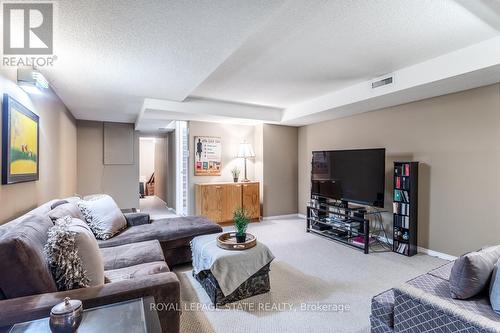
[175,219,445,333]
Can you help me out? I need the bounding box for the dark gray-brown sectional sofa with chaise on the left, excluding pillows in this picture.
[0,200,222,332]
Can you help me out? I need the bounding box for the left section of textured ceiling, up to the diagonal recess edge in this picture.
[44,0,282,121]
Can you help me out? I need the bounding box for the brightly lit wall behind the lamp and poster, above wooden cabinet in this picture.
[189,121,255,214]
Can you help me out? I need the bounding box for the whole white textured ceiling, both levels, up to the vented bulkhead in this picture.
[42,0,500,128]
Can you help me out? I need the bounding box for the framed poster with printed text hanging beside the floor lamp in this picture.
[194,136,222,176]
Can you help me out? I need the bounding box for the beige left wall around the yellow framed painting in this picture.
[0,70,76,223]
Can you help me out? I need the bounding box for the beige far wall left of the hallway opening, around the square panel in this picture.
[77,120,139,208]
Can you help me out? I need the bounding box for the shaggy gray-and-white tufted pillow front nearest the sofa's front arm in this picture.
[44,216,90,291]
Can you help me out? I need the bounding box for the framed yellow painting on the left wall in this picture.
[2,94,40,185]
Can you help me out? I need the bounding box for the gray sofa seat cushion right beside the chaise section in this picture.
[101,240,165,270]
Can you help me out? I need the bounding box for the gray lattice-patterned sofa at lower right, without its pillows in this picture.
[370,262,500,333]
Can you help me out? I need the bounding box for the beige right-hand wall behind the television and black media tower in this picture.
[299,84,500,255]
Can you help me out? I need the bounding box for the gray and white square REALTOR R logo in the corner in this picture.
[3,2,54,55]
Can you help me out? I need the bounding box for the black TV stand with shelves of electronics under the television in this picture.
[306,195,370,254]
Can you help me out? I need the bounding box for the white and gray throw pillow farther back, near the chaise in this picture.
[78,195,127,240]
